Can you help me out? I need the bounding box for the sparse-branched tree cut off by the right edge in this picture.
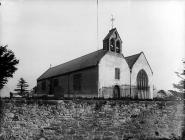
[173,60,185,93]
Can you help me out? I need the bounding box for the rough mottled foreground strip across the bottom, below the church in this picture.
[0,100,184,140]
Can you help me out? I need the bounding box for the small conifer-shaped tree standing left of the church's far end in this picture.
[15,78,29,96]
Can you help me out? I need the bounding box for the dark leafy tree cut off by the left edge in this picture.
[0,45,19,89]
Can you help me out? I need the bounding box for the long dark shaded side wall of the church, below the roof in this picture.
[37,67,98,98]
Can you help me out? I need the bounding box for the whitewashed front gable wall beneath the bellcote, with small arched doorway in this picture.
[98,52,130,98]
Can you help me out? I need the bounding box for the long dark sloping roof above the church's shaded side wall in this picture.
[37,49,107,81]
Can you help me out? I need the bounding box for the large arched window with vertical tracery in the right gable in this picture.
[137,70,148,90]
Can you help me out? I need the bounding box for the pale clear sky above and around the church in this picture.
[0,0,185,94]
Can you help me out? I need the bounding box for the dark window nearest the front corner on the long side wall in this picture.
[73,74,82,90]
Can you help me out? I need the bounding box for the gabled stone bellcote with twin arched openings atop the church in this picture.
[103,28,122,53]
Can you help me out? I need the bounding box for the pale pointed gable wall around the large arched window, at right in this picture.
[131,53,153,99]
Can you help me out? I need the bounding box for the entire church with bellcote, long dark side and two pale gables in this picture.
[37,28,153,99]
